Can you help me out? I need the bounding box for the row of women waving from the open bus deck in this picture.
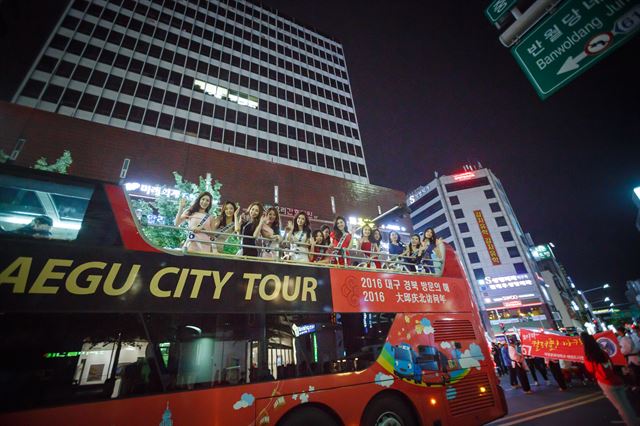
[174,192,443,273]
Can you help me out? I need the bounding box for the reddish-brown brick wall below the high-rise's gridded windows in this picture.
[0,102,411,229]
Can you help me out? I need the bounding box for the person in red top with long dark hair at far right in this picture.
[580,332,639,426]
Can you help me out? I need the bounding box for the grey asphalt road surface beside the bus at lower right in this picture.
[489,377,640,426]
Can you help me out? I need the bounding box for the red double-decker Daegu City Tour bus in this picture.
[0,166,506,426]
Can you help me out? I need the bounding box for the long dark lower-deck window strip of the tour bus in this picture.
[0,313,394,411]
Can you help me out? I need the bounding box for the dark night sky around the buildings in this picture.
[0,0,640,303]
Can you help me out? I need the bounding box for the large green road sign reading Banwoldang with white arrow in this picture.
[511,0,640,99]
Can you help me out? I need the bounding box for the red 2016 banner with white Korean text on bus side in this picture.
[331,269,471,312]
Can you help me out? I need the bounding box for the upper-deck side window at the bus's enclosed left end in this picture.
[0,175,93,240]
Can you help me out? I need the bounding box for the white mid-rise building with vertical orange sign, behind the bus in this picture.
[407,166,559,332]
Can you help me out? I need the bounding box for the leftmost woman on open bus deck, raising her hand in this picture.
[174,192,213,253]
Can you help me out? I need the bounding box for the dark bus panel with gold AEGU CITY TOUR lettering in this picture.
[0,243,332,313]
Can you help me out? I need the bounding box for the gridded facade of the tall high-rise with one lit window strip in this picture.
[13,0,369,183]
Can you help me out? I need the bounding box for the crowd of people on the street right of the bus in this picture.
[492,325,640,426]
